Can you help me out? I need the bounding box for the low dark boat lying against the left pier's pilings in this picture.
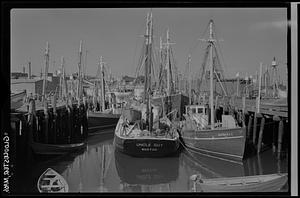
[31,142,87,155]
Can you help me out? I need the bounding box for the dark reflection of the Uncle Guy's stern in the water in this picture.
[115,150,179,192]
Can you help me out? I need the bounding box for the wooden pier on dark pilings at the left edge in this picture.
[10,97,88,156]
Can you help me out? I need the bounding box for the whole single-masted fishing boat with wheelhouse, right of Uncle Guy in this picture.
[181,20,246,161]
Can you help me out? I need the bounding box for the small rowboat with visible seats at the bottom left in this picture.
[37,168,69,193]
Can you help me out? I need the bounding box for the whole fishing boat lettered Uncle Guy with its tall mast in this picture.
[114,13,180,157]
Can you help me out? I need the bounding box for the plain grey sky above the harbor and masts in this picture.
[11,8,287,83]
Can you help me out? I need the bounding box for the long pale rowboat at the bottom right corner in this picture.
[190,173,288,192]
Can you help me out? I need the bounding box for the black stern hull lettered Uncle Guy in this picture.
[114,135,180,157]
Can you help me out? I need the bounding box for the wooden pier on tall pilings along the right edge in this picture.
[231,97,290,159]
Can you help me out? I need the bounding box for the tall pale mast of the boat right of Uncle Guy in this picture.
[208,20,215,129]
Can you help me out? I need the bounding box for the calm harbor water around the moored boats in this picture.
[15,129,289,194]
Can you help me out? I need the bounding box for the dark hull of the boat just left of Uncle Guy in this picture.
[88,112,121,133]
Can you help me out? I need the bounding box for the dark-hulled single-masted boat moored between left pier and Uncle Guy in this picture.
[88,56,122,134]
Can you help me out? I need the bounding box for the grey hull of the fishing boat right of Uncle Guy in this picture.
[181,127,246,161]
